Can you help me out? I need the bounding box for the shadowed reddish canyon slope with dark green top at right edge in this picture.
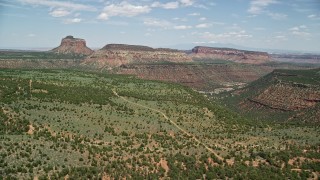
[231,69,320,123]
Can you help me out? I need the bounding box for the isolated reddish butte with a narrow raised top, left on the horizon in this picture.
[51,36,93,55]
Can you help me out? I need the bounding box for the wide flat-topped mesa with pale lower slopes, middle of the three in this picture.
[82,44,192,69]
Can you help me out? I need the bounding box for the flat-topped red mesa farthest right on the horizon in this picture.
[190,46,271,64]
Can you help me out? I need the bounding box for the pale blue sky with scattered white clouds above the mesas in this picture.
[0,0,320,52]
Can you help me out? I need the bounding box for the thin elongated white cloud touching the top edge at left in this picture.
[18,0,96,11]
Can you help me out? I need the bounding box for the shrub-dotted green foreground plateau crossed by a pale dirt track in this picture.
[0,70,320,179]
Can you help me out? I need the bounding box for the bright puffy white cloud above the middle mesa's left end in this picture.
[98,1,151,20]
